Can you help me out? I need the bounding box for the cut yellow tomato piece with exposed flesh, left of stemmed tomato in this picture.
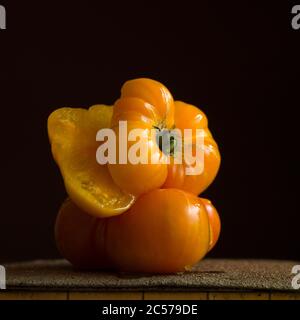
[48,105,135,217]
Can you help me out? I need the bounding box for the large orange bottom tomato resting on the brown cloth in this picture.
[56,189,216,273]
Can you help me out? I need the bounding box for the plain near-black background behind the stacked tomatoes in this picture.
[0,1,300,262]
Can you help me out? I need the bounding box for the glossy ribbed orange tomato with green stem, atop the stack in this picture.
[108,79,220,195]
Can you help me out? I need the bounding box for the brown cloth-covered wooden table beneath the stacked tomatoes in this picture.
[0,259,300,300]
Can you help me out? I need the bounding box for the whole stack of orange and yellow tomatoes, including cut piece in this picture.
[48,79,220,273]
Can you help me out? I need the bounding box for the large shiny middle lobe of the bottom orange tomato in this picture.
[97,189,210,273]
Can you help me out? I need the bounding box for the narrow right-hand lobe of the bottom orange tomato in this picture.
[201,198,221,251]
